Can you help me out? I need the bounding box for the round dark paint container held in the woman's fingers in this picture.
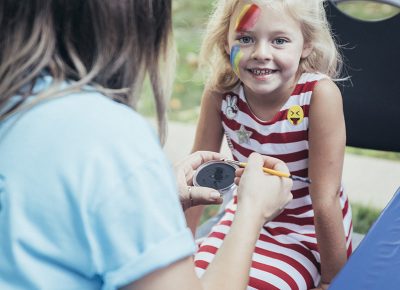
[193,161,237,194]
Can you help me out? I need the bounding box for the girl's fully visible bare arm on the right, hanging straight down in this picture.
[308,80,347,284]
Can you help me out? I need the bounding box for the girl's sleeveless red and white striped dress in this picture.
[195,73,352,290]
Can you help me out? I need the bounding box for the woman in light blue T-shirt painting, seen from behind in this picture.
[0,0,291,289]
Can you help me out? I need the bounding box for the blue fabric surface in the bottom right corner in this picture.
[329,188,400,290]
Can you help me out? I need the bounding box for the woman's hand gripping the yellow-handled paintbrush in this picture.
[235,153,293,223]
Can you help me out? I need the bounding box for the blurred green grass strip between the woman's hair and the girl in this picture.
[138,0,213,123]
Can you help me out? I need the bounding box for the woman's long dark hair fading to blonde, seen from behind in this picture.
[0,0,175,142]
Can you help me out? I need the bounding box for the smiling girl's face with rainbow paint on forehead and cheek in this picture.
[226,1,312,97]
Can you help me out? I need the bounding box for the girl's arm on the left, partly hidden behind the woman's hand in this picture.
[185,88,224,234]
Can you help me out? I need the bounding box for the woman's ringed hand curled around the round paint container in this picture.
[175,151,223,210]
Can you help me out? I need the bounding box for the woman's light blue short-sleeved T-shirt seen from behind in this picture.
[0,77,195,290]
